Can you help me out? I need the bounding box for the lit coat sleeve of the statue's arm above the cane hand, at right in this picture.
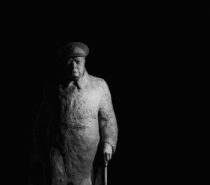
[99,80,118,151]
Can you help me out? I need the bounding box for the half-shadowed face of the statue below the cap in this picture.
[66,57,85,79]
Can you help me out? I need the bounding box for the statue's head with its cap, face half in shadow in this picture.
[60,42,89,79]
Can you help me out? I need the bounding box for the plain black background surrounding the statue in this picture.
[1,3,209,184]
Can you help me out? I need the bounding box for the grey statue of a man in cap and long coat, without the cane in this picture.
[34,42,118,185]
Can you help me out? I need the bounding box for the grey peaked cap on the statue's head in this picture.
[63,42,89,57]
